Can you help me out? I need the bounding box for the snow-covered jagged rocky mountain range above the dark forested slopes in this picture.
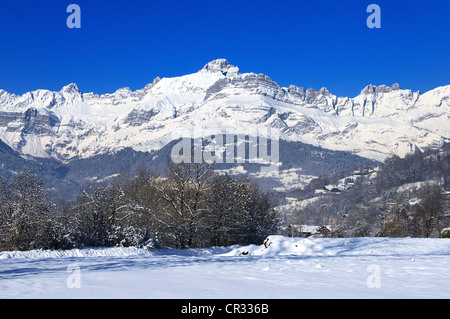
[0,59,450,161]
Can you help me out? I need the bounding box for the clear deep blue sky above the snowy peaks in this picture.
[0,0,450,97]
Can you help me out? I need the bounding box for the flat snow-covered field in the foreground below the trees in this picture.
[0,236,450,299]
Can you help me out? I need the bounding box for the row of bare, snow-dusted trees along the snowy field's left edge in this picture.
[0,164,279,250]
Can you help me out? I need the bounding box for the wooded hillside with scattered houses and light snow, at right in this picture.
[285,144,450,237]
